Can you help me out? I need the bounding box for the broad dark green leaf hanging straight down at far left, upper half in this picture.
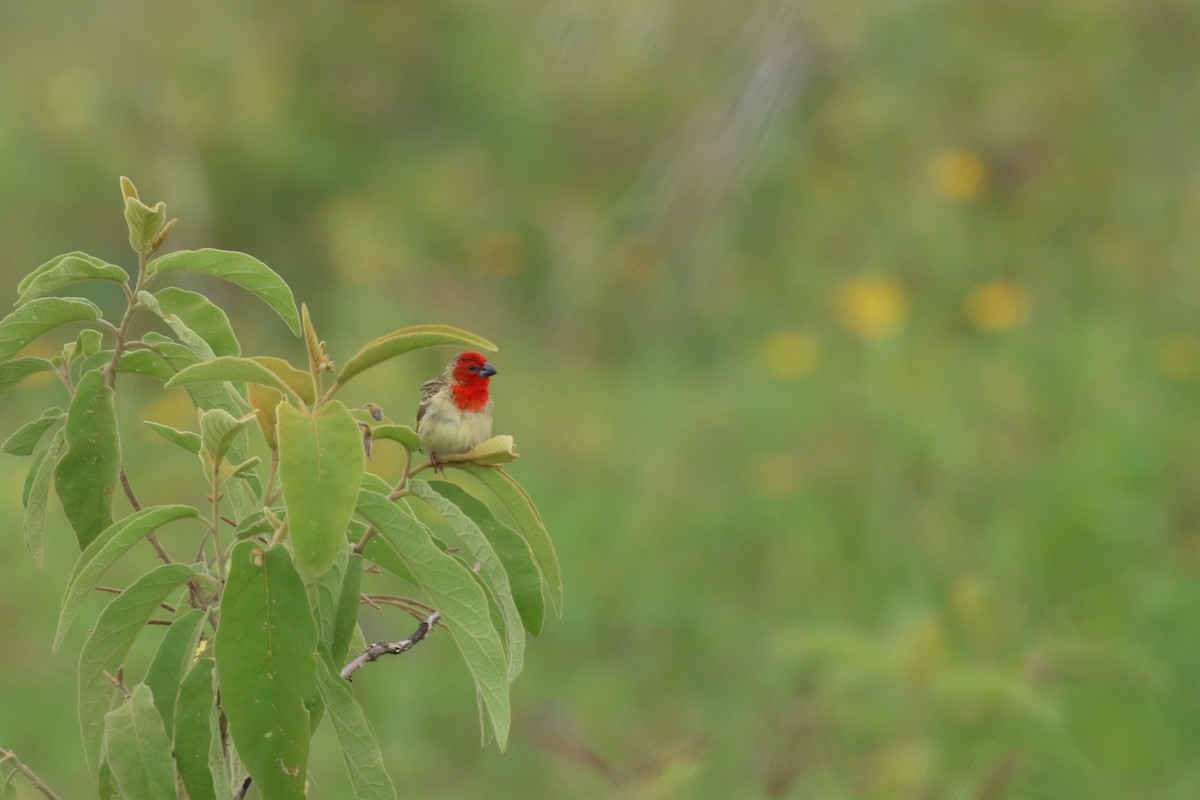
[54,371,121,549]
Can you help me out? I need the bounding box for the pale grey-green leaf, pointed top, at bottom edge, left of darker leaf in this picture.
[104,684,175,800]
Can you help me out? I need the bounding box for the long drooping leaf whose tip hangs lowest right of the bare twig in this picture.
[358,492,511,751]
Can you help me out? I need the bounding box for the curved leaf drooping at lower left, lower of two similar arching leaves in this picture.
[79,564,196,775]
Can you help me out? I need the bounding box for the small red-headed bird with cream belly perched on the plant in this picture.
[416,350,496,470]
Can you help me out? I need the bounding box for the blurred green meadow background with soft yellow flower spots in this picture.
[0,0,1200,800]
